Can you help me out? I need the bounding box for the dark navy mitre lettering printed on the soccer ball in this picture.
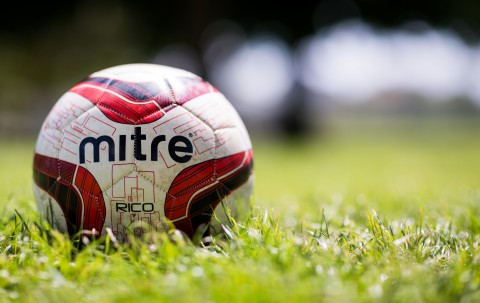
[78,127,193,164]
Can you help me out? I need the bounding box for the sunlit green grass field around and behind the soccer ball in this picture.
[0,119,480,302]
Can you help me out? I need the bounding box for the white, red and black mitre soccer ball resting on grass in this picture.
[33,64,253,241]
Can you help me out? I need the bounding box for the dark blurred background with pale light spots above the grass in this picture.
[0,0,480,137]
